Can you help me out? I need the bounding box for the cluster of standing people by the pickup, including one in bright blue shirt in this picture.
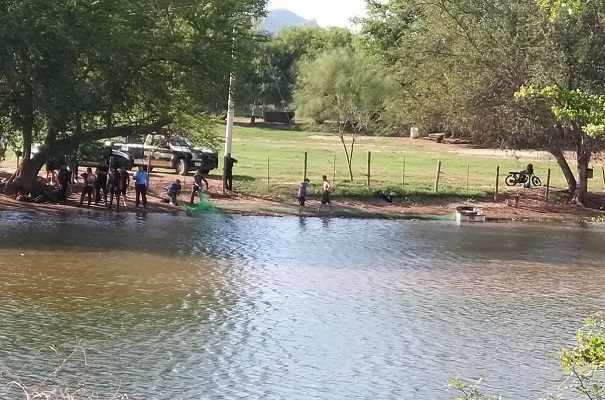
[80,165,149,211]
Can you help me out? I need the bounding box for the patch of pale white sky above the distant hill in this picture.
[269,0,365,27]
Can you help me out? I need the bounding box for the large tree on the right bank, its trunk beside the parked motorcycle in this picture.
[363,0,605,204]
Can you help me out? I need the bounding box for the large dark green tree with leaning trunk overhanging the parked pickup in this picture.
[0,0,265,190]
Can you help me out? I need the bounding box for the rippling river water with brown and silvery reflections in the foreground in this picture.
[0,213,605,400]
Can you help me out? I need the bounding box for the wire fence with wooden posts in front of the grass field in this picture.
[230,151,605,195]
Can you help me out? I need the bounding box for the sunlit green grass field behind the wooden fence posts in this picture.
[219,126,603,198]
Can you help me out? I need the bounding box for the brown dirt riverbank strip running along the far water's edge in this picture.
[0,172,605,223]
